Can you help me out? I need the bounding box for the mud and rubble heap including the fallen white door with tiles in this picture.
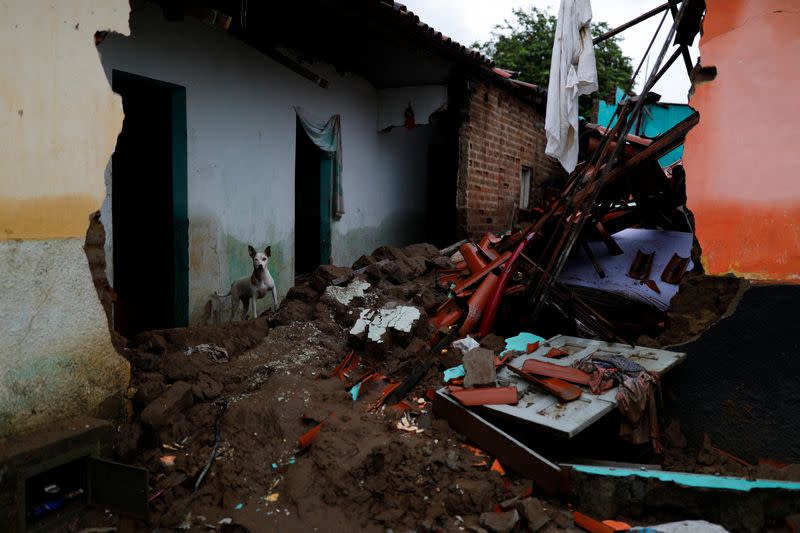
[100,229,800,531]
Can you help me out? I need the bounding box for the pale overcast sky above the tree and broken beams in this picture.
[400,0,697,103]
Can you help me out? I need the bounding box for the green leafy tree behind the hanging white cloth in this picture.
[473,7,633,117]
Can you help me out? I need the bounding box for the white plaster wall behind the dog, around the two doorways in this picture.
[99,4,438,323]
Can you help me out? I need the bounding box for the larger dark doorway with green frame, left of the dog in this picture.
[111,70,189,337]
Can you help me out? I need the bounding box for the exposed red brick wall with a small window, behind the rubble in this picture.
[456,81,564,237]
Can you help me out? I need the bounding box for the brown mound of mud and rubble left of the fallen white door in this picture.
[114,245,552,531]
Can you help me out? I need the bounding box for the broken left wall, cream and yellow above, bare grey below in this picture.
[0,0,130,437]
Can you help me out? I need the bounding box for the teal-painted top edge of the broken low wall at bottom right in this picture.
[563,465,800,492]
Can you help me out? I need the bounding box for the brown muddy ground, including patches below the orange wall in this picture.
[61,245,793,532]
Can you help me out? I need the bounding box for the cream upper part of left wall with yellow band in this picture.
[0,0,129,240]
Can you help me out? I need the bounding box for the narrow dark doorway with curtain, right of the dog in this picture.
[294,118,334,276]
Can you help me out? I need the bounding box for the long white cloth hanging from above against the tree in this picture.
[544,0,597,172]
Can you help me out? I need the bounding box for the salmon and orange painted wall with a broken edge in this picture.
[684,0,800,283]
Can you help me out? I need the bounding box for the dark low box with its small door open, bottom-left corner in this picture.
[0,417,148,532]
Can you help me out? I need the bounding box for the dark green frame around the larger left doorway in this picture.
[111,69,189,327]
